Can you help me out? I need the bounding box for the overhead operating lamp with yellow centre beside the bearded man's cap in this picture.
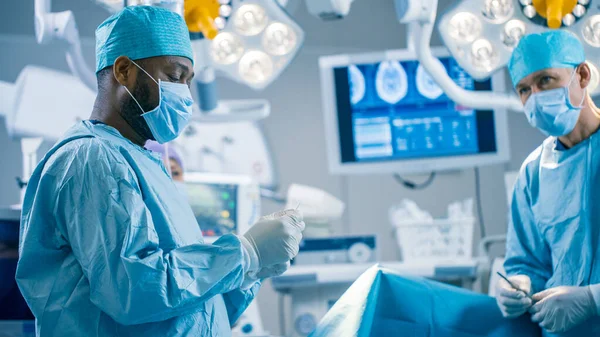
[185,0,304,120]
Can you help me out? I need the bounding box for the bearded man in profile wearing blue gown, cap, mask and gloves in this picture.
[16,6,304,337]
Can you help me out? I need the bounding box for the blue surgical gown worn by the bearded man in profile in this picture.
[16,121,260,337]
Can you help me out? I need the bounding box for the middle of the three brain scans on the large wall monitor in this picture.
[375,61,408,104]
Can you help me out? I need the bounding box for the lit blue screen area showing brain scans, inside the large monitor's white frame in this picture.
[334,57,497,163]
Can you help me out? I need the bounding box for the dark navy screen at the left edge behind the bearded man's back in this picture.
[0,219,34,320]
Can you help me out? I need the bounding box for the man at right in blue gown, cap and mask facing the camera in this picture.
[496,30,600,337]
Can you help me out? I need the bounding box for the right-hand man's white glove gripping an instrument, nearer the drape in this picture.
[496,275,533,318]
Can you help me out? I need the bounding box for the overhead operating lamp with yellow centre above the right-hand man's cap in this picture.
[438,0,600,95]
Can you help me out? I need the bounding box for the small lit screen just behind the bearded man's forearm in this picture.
[186,182,238,236]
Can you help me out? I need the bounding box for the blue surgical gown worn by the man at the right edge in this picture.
[504,133,600,337]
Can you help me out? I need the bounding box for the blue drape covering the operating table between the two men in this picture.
[311,266,541,337]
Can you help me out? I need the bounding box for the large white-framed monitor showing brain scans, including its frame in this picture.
[319,48,509,174]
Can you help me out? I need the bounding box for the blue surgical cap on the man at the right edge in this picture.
[508,30,585,87]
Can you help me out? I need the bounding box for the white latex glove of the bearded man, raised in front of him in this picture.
[243,210,305,270]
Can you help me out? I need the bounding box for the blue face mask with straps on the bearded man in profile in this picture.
[123,61,194,144]
